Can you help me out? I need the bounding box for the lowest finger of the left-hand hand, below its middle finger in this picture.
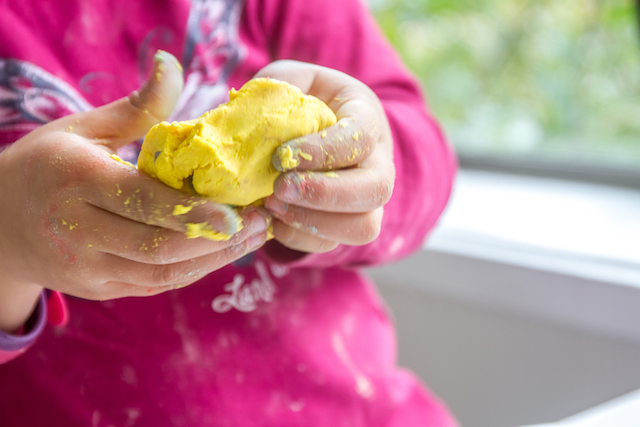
[101,232,267,288]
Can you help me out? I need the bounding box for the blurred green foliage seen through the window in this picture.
[369,0,640,167]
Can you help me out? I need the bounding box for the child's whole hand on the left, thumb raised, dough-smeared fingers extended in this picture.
[0,52,270,318]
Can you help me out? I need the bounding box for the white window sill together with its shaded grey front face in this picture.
[372,170,640,342]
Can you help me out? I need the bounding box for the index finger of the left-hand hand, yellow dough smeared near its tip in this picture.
[81,153,252,240]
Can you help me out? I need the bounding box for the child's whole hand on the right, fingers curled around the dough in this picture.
[258,61,395,252]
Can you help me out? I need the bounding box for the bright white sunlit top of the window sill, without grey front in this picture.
[426,171,640,288]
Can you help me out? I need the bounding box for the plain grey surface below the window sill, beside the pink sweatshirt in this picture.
[372,278,640,427]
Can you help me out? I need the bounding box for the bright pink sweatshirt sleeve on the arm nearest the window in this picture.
[247,0,457,267]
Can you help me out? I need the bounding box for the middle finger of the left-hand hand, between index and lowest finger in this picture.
[78,206,270,265]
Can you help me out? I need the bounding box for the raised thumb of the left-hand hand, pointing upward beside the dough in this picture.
[57,50,183,150]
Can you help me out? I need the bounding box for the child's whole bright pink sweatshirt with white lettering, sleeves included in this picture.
[0,0,456,427]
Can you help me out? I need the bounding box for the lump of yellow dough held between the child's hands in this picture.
[138,78,336,206]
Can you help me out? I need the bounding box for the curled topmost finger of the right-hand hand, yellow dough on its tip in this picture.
[257,61,391,172]
